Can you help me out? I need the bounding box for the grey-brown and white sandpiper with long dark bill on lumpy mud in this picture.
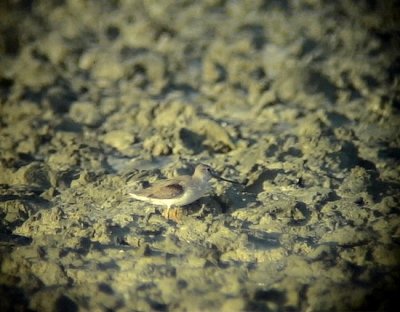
[130,164,238,210]
